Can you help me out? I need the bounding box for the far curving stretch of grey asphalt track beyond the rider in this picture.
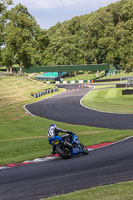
[25,85,133,129]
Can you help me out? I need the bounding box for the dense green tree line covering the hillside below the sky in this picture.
[0,0,133,70]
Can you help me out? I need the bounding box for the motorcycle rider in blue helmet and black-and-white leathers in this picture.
[48,124,74,154]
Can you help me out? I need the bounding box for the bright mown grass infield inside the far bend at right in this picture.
[82,88,133,114]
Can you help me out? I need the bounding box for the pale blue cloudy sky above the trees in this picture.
[13,0,118,29]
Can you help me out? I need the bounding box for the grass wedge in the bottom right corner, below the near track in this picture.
[42,181,133,200]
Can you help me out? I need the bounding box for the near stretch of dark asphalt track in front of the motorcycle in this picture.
[0,137,133,200]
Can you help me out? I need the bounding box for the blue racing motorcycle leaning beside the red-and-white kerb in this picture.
[49,133,89,158]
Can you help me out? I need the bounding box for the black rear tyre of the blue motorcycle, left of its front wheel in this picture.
[56,144,72,159]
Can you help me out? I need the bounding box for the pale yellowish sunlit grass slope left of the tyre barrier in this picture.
[0,76,54,107]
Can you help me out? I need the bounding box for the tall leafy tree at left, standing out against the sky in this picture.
[4,4,48,70]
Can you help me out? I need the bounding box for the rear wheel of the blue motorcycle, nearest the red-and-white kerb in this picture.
[56,144,72,158]
